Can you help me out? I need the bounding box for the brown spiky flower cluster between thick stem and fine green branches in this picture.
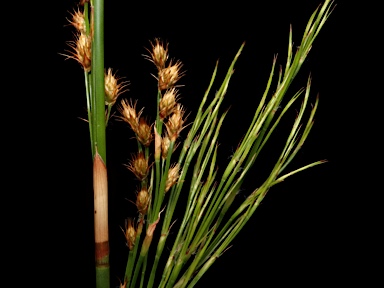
[118,38,185,254]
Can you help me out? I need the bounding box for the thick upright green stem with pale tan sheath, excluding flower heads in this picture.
[91,0,110,288]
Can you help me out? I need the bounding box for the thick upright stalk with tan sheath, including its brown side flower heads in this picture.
[65,0,127,288]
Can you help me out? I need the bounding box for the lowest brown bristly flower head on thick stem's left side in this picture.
[64,33,92,72]
